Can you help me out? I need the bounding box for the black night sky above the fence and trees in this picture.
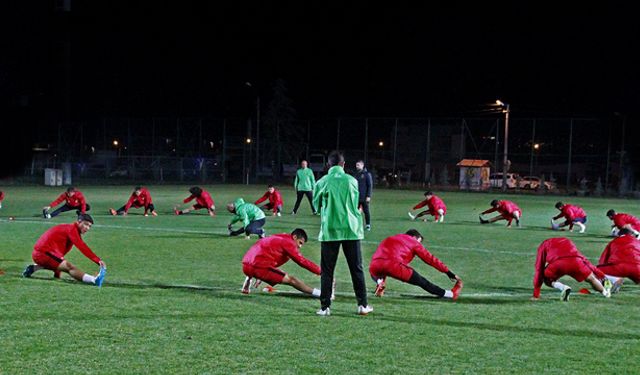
[0,0,640,176]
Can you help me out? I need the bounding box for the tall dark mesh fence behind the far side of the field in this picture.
[25,117,636,191]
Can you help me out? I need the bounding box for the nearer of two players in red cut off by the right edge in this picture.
[598,229,640,293]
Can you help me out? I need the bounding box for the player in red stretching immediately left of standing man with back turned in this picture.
[242,228,320,298]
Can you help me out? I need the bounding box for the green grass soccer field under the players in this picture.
[0,185,640,374]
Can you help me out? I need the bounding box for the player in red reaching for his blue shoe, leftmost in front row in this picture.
[22,214,107,286]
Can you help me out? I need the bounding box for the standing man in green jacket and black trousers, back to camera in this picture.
[313,151,373,316]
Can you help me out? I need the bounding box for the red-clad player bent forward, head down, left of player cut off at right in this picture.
[533,237,612,301]
